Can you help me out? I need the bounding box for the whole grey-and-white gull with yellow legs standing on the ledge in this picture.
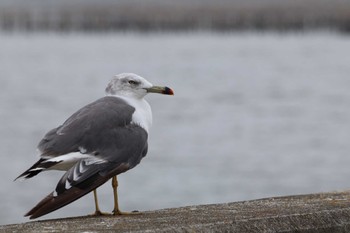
[16,73,174,219]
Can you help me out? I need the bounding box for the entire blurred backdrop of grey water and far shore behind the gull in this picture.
[0,0,350,224]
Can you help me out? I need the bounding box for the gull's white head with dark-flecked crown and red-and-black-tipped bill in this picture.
[106,73,174,99]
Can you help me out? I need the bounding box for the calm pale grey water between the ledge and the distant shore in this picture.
[0,33,350,224]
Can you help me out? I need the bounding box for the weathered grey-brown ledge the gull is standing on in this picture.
[0,192,350,233]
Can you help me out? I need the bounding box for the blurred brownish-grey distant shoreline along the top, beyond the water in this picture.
[0,1,350,33]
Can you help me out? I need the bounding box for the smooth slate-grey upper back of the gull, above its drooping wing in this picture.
[38,97,135,157]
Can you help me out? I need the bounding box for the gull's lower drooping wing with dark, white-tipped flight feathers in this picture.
[25,125,148,219]
